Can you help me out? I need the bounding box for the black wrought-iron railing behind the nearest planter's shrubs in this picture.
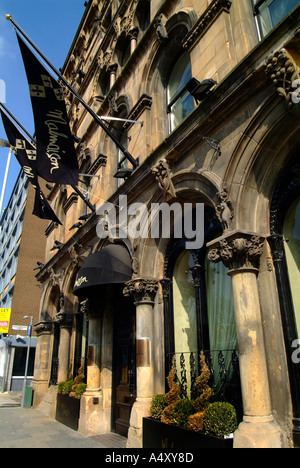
[168,350,242,411]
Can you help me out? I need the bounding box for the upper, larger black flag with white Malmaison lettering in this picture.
[17,35,78,185]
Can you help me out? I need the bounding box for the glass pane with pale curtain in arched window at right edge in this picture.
[283,197,300,336]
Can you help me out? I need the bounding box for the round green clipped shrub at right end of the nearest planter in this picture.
[204,402,238,437]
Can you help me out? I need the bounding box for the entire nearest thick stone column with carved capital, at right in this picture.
[208,231,283,448]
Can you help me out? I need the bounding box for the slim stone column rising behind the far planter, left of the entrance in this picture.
[56,310,73,383]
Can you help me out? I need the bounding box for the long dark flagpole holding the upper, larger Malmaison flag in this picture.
[5,15,138,169]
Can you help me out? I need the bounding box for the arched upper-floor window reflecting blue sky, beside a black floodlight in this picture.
[168,53,194,131]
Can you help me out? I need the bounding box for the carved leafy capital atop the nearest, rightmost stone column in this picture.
[208,231,265,271]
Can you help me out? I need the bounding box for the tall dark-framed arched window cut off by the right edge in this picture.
[269,152,300,444]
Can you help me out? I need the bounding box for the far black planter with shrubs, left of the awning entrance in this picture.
[55,365,86,431]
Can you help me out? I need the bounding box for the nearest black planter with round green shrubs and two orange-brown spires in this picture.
[143,353,238,448]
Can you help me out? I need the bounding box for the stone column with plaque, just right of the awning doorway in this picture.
[124,278,159,448]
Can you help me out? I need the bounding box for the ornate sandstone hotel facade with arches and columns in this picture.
[33,0,300,448]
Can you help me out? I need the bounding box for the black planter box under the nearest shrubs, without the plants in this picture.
[143,418,233,449]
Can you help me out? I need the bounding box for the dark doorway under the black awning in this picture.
[112,286,136,437]
